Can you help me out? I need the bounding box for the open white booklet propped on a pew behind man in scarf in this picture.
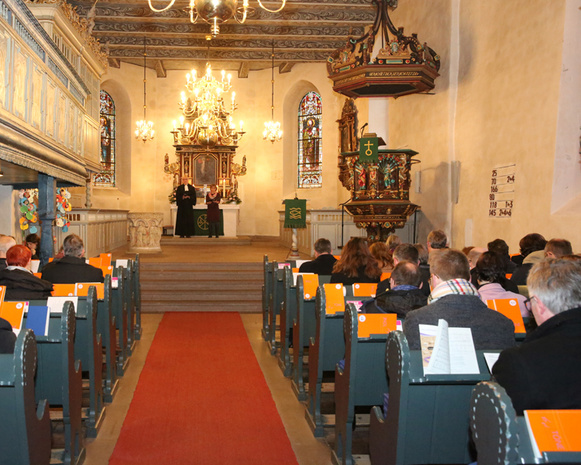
[419,320,480,375]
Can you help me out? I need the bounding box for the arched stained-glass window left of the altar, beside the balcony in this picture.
[93,90,115,187]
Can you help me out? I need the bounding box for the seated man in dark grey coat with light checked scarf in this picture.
[403,249,515,350]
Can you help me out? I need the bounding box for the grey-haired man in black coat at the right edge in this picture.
[492,259,581,415]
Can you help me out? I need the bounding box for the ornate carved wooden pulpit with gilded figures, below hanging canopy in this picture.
[338,99,419,240]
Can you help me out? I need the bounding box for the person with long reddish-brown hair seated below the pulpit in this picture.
[331,237,381,285]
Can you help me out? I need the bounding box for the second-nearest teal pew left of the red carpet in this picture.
[35,302,85,465]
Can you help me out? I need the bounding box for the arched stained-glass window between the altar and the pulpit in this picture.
[298,92,323,188]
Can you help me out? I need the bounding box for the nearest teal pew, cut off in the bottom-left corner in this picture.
[0,329,51,465]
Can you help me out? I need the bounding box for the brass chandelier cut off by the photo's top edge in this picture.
[147,0,286,37]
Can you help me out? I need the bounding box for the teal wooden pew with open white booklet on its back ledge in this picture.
[369,331,492,465]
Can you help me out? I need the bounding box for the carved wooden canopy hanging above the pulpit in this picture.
[327,0,440,98]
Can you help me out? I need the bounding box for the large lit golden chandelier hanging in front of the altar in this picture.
[171,62,244,147]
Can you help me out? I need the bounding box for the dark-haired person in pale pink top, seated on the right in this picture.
[474,252,531,317]
